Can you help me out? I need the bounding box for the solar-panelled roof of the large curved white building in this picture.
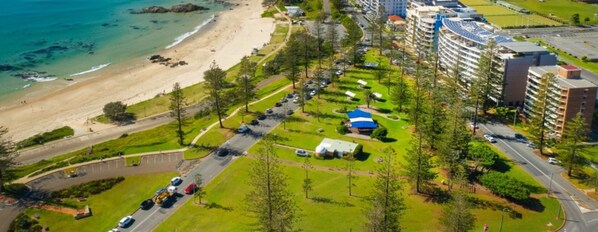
[442,18,513,44]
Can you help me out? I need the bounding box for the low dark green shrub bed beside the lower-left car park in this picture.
[51,176,125,198]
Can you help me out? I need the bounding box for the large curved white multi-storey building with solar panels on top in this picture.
[438,19,557,106]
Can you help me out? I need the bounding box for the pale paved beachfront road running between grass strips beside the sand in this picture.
[15,103,206,164]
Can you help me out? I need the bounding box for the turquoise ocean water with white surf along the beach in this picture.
[0,0,226,98]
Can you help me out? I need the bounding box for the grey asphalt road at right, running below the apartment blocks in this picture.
[480,124,598,232]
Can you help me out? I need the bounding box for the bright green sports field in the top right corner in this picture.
[507,0,598,24]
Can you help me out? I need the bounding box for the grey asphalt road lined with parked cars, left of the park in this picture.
[116,96,299,232]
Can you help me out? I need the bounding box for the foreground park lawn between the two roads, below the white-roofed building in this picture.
[156,157,562,231]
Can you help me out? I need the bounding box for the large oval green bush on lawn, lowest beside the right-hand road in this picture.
[479,172,529,201]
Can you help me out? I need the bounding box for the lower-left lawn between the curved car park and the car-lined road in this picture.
[25,172,177,232]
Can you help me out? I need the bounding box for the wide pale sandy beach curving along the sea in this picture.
[0,0,275,141]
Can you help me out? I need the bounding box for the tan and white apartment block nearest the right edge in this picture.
[523,65,598,137]
